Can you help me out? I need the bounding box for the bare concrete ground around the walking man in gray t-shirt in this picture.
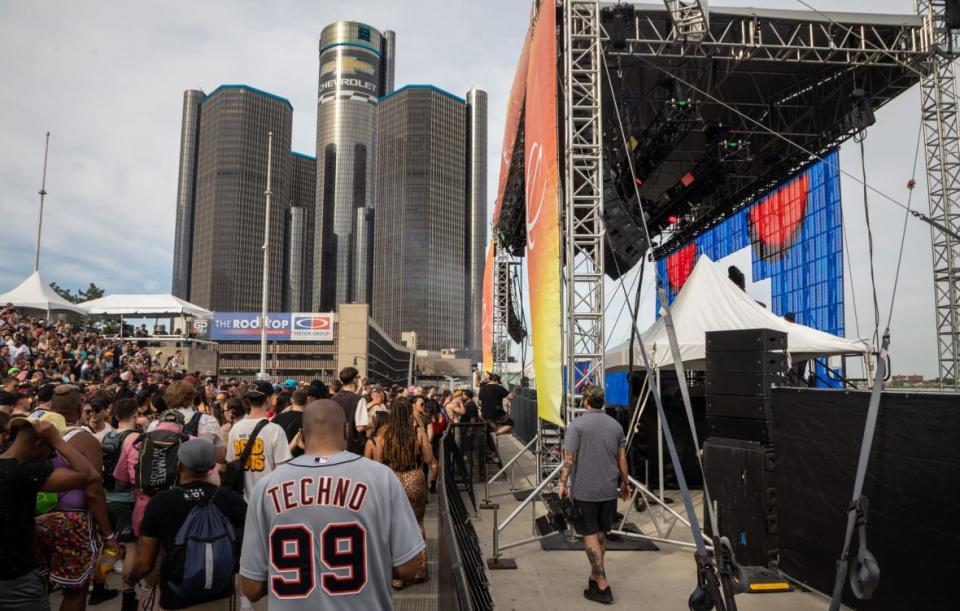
[474,436,829,611]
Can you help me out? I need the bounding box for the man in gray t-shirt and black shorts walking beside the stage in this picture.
[558,386,630,604]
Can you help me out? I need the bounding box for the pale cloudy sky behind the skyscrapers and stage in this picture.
[0,0,936,376]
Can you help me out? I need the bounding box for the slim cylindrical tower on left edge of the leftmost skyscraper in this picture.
[170,89,205,299]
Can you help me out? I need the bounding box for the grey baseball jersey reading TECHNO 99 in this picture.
[240,452,426,611]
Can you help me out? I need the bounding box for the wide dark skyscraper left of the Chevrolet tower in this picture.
[180,85,293,311]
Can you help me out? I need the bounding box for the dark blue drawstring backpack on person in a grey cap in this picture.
[164,492,239,602]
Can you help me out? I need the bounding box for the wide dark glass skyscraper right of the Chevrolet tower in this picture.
[372,85,486,350]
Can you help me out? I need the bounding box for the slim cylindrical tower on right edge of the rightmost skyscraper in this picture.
[465,89,487,350]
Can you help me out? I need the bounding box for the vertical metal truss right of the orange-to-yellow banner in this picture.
[561,0,605,430]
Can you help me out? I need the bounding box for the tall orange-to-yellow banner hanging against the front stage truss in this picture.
[524,2,563,426]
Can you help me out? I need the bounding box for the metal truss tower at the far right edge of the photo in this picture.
[916,0,960,390]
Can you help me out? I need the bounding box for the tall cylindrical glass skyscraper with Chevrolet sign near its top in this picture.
[313,21,395,310]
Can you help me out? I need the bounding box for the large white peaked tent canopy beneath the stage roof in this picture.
[605,255,871,371]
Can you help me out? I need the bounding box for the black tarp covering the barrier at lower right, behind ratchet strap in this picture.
[773,389,960,611]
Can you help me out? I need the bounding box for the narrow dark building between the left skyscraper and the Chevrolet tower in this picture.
[284,152,317,312]
